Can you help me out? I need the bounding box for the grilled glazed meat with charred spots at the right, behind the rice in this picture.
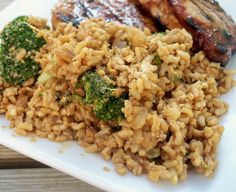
[139,0,236,66]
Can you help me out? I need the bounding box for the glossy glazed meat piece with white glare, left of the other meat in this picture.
[52,0,157,32]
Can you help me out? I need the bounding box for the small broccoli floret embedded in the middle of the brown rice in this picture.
[79,71,127,121]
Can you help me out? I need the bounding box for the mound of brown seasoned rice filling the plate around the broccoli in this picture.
[0,19,234,184]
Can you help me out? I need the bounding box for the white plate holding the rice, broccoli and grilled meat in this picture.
[0,0,236,192]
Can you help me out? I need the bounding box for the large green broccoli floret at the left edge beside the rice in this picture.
[0,16,46,85]
